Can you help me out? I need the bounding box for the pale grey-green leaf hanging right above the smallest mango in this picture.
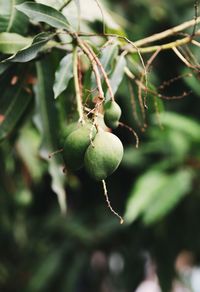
[106,54,126,99]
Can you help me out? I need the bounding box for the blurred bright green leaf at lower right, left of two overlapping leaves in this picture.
[125,170,167,223]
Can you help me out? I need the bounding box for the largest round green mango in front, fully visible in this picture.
[84,131,124,181]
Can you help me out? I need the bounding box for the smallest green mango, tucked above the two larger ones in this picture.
[104,100,122,129]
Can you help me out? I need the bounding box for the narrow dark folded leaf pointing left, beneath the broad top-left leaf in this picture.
[1,32,54,63]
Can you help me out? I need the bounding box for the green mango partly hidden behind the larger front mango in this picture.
[63,123,96,170]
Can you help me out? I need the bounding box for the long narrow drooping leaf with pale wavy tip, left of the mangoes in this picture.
[35,58,66,213]
